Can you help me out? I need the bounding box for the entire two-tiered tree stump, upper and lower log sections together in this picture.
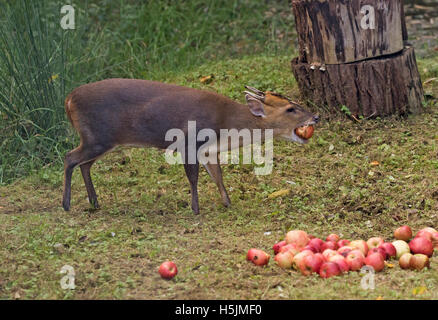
[292,0,423,117]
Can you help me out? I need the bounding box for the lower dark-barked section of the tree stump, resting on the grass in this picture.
[292,47,423,117]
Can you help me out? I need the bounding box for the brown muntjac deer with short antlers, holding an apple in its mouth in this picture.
[63,79,319,214]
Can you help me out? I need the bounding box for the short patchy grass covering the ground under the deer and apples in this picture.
[0,55,438,299]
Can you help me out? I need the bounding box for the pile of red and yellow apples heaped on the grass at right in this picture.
[246,226,438,278]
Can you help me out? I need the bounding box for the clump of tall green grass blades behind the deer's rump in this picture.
[0,0,107,184]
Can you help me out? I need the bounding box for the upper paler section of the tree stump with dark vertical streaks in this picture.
[292,0,406,64]
